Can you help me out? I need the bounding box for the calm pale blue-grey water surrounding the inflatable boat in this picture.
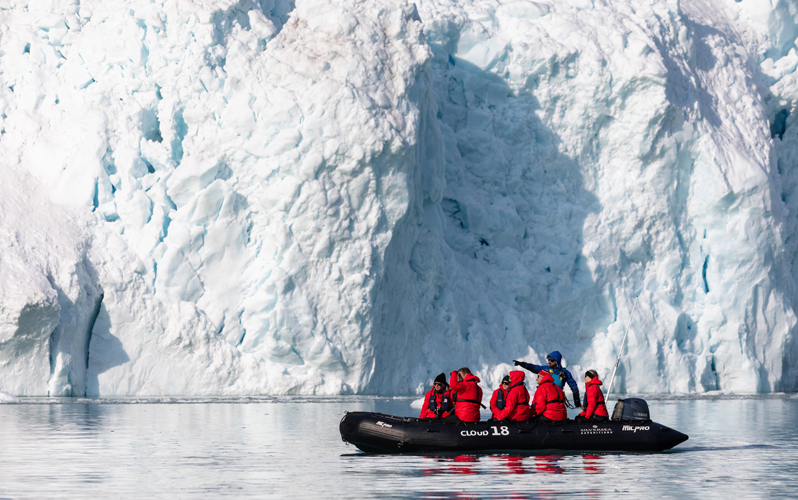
[0,396,798,499]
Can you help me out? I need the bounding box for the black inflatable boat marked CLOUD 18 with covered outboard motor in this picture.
[340,398,687,453]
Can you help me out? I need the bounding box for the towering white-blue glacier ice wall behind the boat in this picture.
[0,0,798,397]
